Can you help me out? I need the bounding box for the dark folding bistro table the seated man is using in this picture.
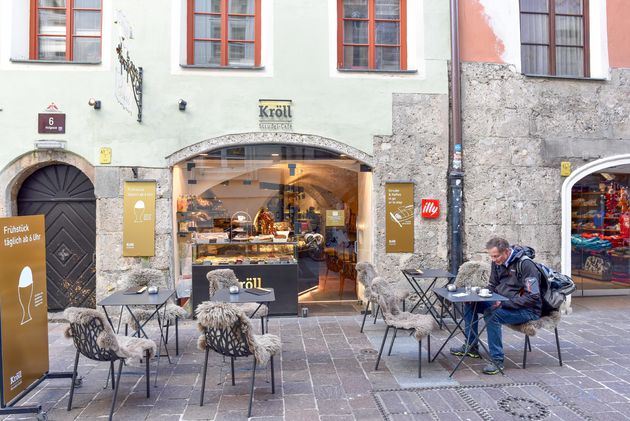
[431,288,509,377]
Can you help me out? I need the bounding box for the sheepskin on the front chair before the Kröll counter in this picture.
[196,301,280,364]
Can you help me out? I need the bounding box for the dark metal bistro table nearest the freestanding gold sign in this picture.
[98,288,175,387]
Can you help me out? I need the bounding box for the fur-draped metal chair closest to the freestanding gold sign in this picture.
[64,307,156,421]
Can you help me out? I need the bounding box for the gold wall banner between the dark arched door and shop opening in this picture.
[123,181,156,256]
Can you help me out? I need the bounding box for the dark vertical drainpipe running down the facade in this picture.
[448,0,464,274]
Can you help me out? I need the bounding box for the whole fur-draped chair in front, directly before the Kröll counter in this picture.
[196,301,280,417]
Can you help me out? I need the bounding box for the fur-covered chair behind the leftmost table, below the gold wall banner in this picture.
[122,268,188,355]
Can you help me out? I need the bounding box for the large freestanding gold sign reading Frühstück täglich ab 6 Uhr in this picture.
[0,215,48,406]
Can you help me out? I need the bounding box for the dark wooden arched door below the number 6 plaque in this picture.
[17,164,96,310]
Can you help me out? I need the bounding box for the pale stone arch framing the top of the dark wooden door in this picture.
[0,151,94,216]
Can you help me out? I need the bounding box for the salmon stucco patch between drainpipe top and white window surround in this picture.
[459,0,506,63]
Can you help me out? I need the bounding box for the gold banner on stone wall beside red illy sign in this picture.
[385,183,414,253]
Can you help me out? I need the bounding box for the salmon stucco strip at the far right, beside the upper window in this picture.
[606,0,630,67]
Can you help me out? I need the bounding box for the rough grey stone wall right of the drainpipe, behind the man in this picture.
[462,63,630,268]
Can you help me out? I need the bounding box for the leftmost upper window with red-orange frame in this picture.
[29,0,102,63]
